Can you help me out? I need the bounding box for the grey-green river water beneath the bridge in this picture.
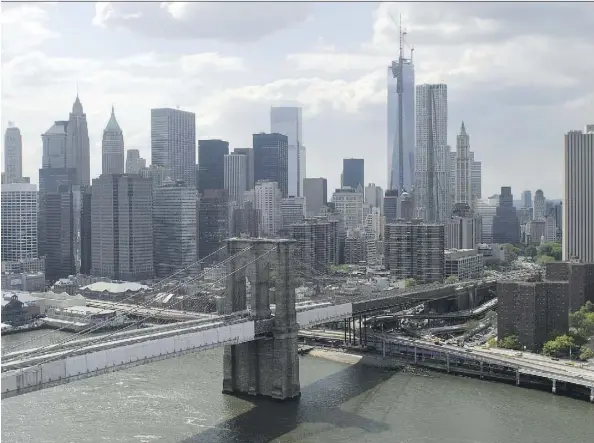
[2,331,594,443]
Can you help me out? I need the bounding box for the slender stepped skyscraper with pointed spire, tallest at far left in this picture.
[66,94,91,186]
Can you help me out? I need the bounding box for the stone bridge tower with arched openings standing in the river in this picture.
[223,238,301,400]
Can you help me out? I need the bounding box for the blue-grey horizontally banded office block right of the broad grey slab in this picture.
[153,179,200,278]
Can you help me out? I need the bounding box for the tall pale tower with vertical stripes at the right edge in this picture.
[562,125,594,262]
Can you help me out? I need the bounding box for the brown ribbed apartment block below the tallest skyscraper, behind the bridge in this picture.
[384,220,445,283]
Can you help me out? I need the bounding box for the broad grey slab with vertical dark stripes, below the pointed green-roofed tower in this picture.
[91,175,154,281]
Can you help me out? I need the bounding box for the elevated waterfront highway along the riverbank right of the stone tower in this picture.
[299,329,594,401]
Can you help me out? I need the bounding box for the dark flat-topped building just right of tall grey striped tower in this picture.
[198,140,229,194]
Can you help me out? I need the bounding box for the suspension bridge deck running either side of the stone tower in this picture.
[1,272,528,398]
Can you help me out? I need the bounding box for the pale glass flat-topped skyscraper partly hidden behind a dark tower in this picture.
[270,106,305,197]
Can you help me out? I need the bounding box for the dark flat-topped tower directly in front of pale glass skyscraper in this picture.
[253,132,289,198]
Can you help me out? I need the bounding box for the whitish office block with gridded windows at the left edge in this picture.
[0,183,38,261]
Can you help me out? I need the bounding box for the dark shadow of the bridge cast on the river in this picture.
[181,363,394,443]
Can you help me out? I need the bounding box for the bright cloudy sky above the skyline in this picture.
[0,2,594,198]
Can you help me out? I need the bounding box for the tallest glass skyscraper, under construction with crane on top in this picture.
[388,25,415,191]
